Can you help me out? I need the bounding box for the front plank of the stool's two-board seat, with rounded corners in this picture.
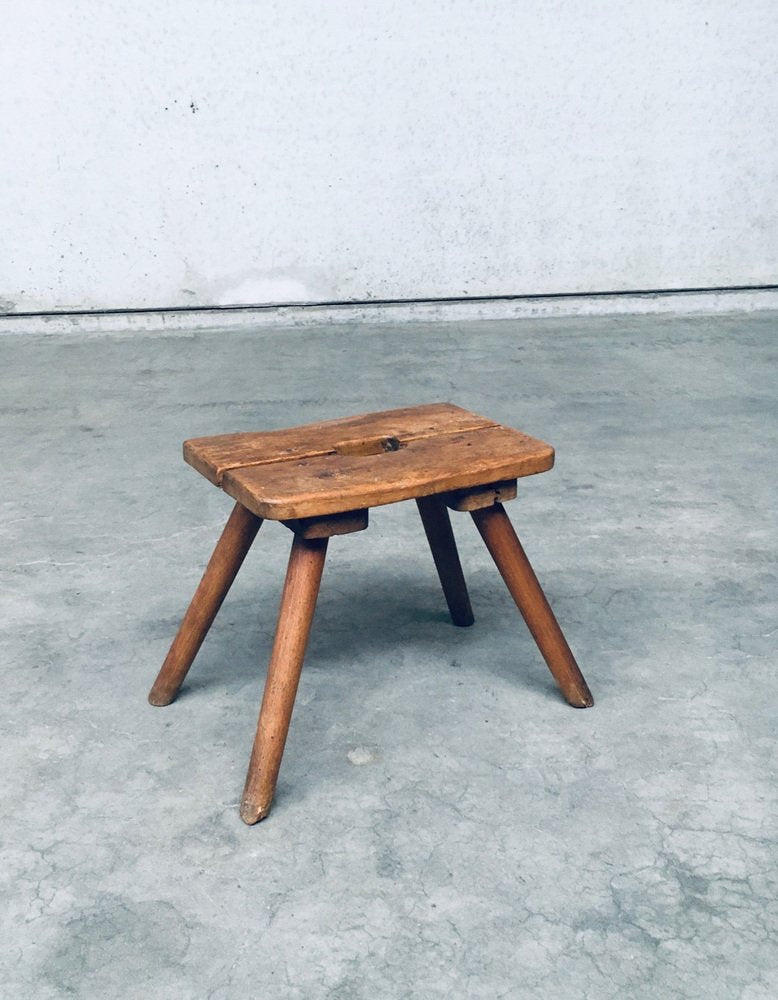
[222,426,554,520]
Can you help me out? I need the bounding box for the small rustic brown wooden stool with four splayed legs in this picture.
[149,403,593,823]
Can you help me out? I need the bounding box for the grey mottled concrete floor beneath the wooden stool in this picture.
[0,313,778,1000]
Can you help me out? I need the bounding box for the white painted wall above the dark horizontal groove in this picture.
[0,0,778,311]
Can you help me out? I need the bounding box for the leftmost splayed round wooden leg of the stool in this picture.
[149,503,262,705]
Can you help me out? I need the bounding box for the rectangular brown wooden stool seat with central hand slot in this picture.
[184,403,554,520]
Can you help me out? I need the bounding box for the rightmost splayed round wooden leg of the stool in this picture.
[471,503,594,708]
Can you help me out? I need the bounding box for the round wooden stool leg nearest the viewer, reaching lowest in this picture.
[240,535,329,825]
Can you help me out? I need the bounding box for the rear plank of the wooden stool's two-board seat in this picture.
[184,403,496,486]
